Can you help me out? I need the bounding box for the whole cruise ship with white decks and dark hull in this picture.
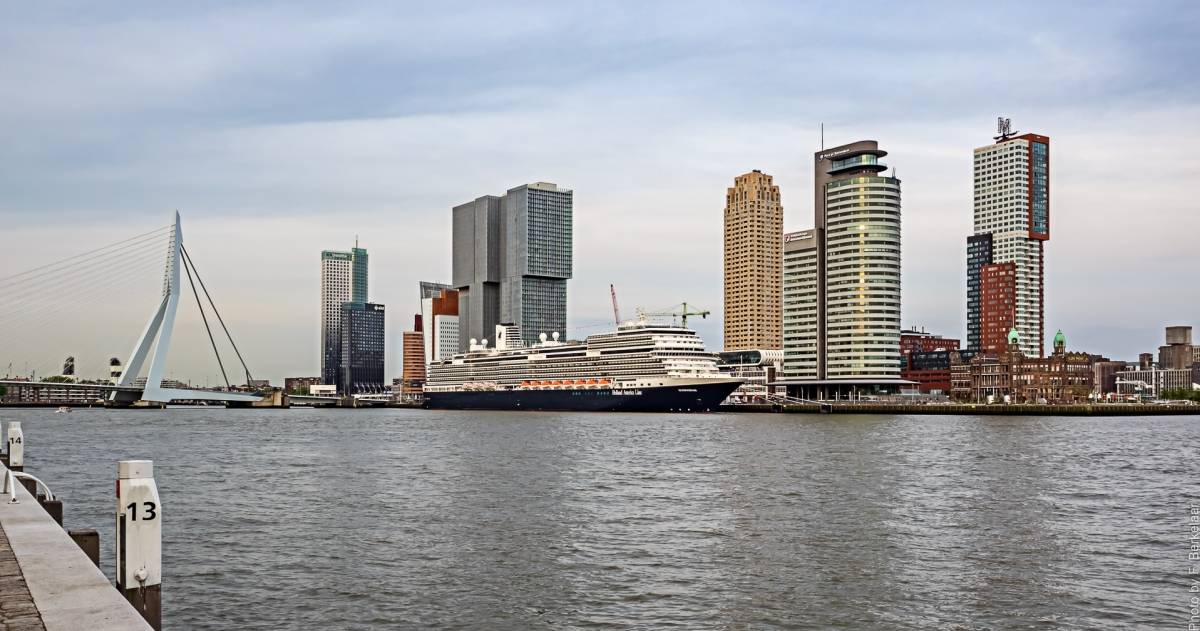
[425,319,742,411]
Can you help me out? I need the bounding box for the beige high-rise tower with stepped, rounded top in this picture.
[725,169,784,350]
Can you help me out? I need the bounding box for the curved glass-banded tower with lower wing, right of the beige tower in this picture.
[784,140,901,396]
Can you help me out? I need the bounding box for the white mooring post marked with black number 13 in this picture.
[116,461,162,630]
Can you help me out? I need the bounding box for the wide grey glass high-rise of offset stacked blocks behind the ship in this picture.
[451,182,574,351]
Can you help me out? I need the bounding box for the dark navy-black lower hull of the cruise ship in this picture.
[425,379,740,411]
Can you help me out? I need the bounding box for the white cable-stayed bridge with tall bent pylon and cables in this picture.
[0,212,276,405]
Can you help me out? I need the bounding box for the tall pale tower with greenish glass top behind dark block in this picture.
[320,244,367,385]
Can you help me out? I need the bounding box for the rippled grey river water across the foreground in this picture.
[0,408,1200,630]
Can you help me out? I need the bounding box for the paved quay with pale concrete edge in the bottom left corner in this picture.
[0,465,151,631]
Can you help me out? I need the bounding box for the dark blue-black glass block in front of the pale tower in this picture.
[337,302,386,395]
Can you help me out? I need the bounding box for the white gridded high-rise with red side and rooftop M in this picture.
[967,119,1050,357]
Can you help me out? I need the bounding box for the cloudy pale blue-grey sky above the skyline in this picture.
[0,1,1200,384]
